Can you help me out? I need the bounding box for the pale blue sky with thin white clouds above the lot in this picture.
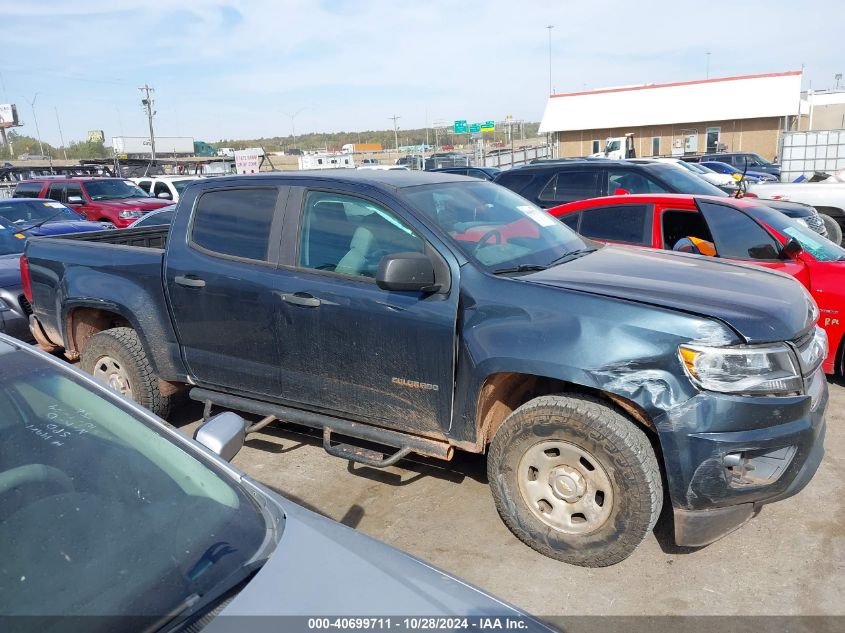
[0,0,845,144]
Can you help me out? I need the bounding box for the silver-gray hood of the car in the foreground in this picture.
[205,488,550,632]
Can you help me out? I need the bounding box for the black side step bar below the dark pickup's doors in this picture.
[190,387,454,468]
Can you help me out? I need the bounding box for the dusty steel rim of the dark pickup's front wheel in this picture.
[517,440,613,534]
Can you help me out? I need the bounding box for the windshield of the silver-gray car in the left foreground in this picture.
[0,349,266,631]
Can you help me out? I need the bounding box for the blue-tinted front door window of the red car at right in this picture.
[698,201,780,260]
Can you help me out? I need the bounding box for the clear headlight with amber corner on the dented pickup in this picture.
[678,344,803,396]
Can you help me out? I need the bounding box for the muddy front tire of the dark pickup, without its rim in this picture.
[487,395,663,567]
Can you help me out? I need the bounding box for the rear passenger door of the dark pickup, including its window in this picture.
[164,185,289,395]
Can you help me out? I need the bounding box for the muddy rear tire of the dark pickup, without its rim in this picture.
[79,327,173,419]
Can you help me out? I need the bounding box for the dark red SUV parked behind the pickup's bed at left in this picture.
[14,178,173,229]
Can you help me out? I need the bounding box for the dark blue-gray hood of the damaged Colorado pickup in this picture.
[522,246,813,343]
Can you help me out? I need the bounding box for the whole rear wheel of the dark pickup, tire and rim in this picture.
[79,327,171,418]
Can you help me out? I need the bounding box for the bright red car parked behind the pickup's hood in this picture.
[548,194,845,374]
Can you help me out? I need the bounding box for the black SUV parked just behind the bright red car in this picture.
[493,158,826,230]
